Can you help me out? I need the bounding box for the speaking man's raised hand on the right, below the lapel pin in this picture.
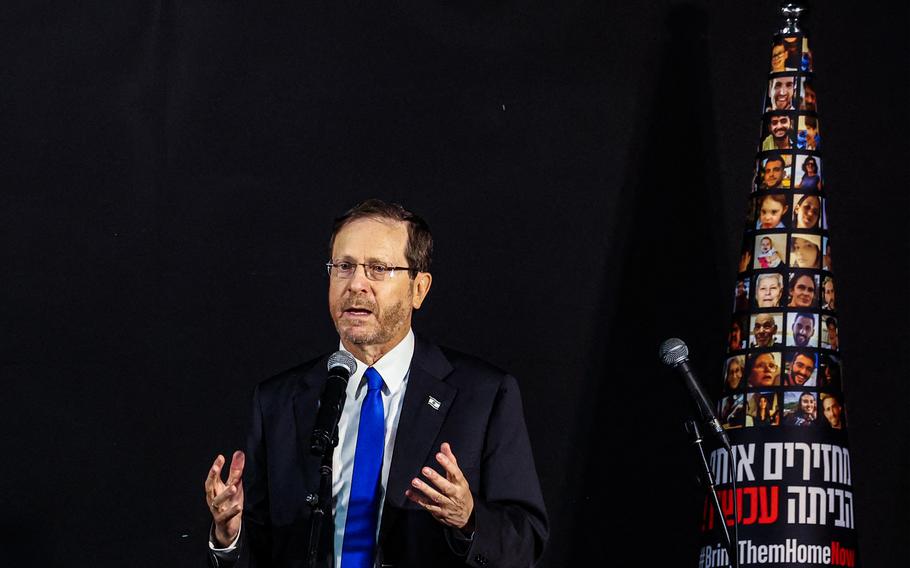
[405,442,474,533]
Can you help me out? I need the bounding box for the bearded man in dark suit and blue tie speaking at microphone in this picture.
[205,200,547,568]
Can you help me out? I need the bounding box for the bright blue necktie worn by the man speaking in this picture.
[341,367,385,568]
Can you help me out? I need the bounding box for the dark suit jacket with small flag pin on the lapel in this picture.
[216,337,547,568]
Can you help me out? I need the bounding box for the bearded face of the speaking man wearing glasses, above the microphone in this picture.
[329,218,423,355]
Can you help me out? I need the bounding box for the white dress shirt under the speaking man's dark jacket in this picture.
[209,330,414,568]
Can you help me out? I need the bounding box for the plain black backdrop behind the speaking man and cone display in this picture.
[0,0,910,567]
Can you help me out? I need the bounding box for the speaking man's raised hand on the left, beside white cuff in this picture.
[205,450,246,548]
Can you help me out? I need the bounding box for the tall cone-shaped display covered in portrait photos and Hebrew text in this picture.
[698,8,859,568]
